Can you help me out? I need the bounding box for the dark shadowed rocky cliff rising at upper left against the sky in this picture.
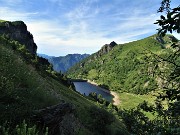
[0,21,37,55]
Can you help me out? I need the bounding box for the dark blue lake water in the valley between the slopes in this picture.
[73,82,113,102]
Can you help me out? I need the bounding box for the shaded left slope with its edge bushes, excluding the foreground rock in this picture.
[0,22,128,135]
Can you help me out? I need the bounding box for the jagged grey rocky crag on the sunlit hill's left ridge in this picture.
[97,41,117,57]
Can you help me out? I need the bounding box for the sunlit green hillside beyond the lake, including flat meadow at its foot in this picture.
[67,35,177,109]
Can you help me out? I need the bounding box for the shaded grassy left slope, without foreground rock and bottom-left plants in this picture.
[0,31,128,134]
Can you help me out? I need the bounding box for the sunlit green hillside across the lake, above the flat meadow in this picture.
[67,35,176,94]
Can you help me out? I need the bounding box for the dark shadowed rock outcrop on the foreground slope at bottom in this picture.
[33,103,81,135]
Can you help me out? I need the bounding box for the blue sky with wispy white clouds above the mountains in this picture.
[0,0,180,56]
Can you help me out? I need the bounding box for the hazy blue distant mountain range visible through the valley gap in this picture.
[38,54,89,73]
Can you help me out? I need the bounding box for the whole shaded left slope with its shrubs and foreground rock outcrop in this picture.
[0,20,128,135]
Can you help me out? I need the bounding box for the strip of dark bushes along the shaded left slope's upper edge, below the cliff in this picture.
[0,37,68,85]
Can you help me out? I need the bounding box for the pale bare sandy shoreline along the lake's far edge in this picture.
[87,80,120,105]
